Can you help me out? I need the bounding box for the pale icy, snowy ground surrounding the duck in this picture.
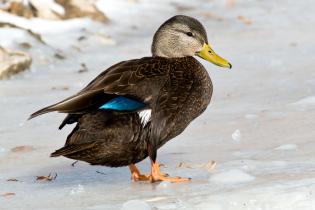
[0,0,315,210]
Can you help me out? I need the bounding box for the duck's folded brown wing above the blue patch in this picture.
[29,57,171,119]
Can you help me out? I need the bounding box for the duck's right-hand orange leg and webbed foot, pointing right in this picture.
[149,161,190,183]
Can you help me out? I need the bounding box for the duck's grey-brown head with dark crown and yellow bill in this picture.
[151,15,232,68]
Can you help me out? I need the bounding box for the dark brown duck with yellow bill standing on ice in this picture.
[29,15,232,182]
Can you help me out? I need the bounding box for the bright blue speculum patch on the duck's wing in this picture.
[99,96,145,111]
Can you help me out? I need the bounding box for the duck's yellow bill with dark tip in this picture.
[196,43,232,69]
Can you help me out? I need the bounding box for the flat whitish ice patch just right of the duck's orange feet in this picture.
[210,169,255,184]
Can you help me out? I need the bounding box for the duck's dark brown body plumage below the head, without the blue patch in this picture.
[50,57,212,167]
